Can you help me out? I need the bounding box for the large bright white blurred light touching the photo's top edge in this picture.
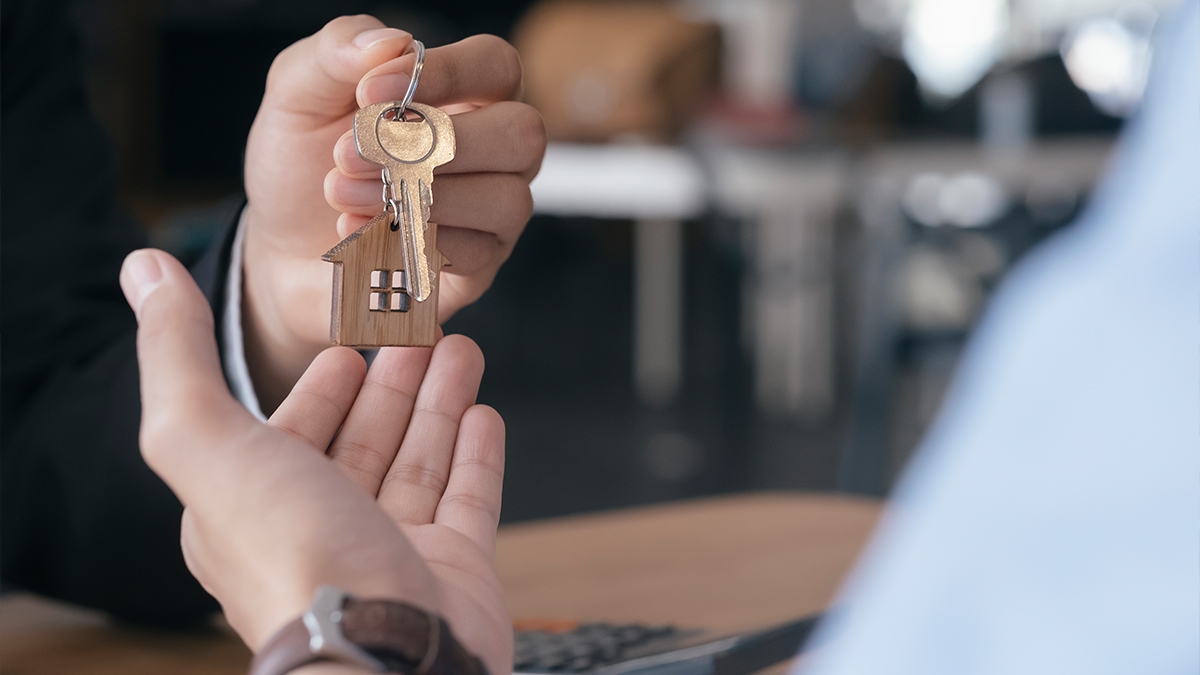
[902,0,1008,98]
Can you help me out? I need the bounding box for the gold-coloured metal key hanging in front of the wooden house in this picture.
[354,101,455,303]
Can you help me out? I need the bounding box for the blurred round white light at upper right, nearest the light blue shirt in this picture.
[1062,13,1153,117]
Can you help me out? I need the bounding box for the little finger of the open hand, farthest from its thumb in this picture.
[433,406,504,555]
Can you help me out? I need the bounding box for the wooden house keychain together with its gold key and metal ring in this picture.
[322,41,455,347]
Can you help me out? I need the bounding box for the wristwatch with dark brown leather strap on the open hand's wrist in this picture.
[250,586,487,675]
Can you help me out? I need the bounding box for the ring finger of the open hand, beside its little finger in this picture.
[379,335,484,525]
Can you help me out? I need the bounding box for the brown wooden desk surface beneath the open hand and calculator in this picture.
[0,494,881,675]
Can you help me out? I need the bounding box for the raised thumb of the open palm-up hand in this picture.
[120,249,250,485]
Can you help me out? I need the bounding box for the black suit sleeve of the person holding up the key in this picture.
[0,0,236,625]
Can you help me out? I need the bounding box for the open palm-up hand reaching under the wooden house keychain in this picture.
[121,250,512,674]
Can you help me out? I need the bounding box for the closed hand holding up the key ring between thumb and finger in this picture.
[244,16,546,411]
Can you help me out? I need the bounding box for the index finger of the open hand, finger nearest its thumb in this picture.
[268,347,366,452]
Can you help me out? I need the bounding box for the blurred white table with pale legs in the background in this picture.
[532,143,846,419]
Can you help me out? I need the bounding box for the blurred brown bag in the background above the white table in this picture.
[514,0,720,142]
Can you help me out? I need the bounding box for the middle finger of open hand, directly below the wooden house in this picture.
[329,347,433,497]
